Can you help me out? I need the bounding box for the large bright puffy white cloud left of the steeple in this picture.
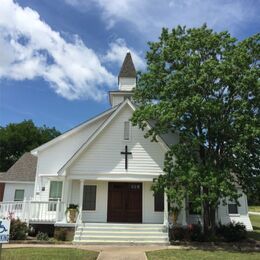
[0,0,116,101]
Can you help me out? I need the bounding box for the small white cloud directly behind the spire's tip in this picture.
[102,39,146,70]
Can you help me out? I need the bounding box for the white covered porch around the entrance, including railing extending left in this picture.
[0,176,186,227]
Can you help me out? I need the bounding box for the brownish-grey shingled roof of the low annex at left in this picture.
[0,153,37,182]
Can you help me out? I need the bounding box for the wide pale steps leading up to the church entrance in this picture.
[74,223,169,244]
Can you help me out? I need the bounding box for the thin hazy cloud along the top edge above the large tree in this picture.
[66,0,259,39]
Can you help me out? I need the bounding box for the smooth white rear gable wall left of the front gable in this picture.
[37,115,109,175]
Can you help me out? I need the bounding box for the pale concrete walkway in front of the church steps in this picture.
[3,244,179,260]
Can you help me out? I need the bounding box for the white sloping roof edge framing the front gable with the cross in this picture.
[58,98,168,174]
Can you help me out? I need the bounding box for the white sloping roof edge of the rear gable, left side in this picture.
[31,105,119,155]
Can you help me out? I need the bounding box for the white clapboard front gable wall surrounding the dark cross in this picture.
[69,106,174,177]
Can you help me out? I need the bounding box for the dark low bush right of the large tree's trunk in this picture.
[216,222,247,242]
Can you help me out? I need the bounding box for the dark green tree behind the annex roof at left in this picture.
[0,120,60,171]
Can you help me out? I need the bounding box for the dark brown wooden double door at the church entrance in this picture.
[107,182,142,223]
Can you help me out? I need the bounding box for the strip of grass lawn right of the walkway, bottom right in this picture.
[146,249,260,260]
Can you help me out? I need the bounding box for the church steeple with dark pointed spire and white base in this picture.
[109,51,136,106]
